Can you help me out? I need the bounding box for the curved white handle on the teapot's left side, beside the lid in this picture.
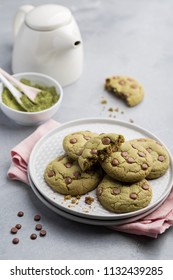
[13,5,34,37]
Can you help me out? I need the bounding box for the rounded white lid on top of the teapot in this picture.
[25,4,72,31]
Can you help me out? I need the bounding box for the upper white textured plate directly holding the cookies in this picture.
[28,118,173,220]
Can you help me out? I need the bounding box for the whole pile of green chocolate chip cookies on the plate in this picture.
[44,131,169,213]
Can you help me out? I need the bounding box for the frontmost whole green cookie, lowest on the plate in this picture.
[96,175,152,213]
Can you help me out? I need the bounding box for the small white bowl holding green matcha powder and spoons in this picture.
[0,72,63,125]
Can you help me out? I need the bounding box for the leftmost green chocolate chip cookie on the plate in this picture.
[44,155,102,196]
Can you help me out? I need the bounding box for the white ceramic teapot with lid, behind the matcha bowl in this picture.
[12,4,83,86]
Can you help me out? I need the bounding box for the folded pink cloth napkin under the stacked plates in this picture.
[7,120,173,238]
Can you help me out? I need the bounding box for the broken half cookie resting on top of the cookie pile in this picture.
[78,133,124,170]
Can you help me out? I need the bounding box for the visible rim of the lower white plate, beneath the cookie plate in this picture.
[28,174,168,226]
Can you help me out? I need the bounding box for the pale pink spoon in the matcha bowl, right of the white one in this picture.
[0,68,41,103]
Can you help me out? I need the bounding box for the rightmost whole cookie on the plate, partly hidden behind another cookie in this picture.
[131,138,170,179]
